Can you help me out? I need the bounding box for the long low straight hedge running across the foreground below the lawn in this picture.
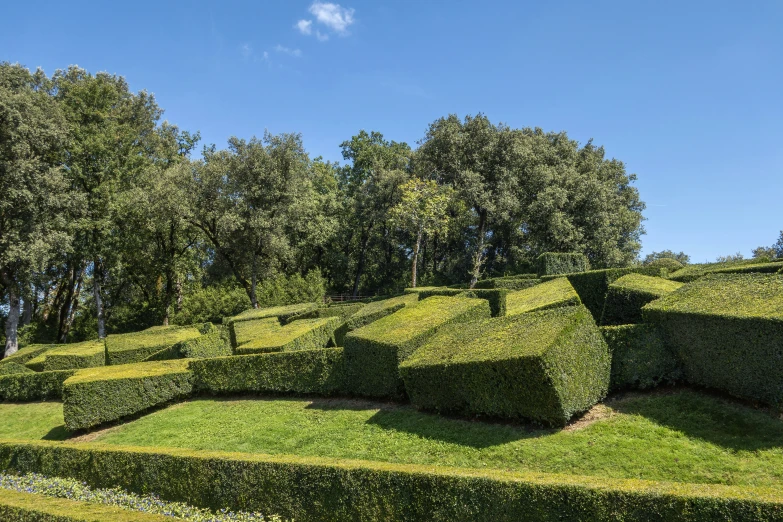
[0,441,783,522]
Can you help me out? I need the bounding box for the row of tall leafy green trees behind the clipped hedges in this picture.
[0,62,645,354]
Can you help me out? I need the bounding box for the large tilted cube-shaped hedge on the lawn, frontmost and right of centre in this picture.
[400,306,611,426]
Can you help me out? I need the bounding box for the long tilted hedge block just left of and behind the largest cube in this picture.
[345,296,490,398]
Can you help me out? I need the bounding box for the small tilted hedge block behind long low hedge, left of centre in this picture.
[231,317,340,355]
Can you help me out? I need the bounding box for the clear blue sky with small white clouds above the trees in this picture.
[0,0,783,261]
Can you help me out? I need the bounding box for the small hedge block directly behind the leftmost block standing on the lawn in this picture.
[106,323,204,365]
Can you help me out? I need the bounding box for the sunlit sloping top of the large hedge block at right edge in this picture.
[644,274,783,321]
